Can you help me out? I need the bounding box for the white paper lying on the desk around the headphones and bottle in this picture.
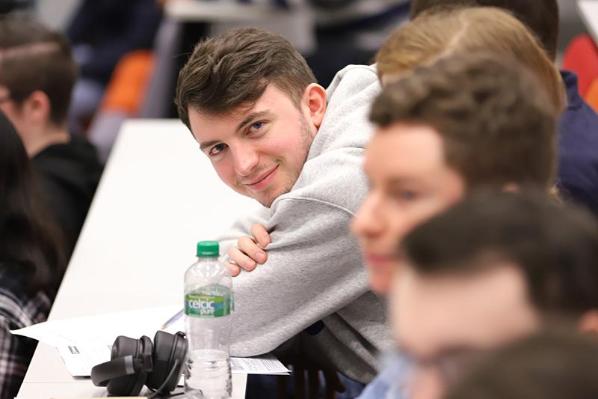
[11,306,290,377]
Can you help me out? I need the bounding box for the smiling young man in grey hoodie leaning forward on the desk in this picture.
[176,29,390,394]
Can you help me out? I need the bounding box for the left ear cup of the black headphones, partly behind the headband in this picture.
[106,335,152,396]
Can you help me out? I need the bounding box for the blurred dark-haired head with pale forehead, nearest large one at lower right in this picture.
[390,192,598,399]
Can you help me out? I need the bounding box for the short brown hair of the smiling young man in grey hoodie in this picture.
[175,28,316,127]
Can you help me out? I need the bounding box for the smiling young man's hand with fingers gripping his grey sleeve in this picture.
[228,224,271,277]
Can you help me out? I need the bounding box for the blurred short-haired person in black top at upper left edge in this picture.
[0,16,102,255]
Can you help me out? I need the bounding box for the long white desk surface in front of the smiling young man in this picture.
[18,120,258,399]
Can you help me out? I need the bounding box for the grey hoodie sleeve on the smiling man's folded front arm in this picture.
[231,195,368,356]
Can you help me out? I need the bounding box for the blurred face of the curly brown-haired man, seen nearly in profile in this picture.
[352,123,465,294]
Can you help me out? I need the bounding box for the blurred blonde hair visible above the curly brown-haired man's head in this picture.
[376,7,565,114]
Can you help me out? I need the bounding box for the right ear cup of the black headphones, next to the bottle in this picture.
[147,331,187,394]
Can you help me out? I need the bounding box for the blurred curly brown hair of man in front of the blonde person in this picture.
[370,52,557,190]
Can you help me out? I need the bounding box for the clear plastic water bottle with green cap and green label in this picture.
[185,241,233,399]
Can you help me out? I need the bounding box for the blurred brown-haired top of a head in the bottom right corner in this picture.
[445,326,598,399]
